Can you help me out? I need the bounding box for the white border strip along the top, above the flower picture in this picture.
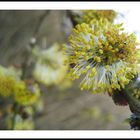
[0,2,140,10]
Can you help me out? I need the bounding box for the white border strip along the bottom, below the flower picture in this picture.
[0,130,140,139]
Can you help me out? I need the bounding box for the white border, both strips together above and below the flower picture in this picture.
[0,2,140,138]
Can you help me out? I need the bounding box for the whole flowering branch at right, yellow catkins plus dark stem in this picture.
[65,10,140,129]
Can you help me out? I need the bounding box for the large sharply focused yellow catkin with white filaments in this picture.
[66,18,140,93]
